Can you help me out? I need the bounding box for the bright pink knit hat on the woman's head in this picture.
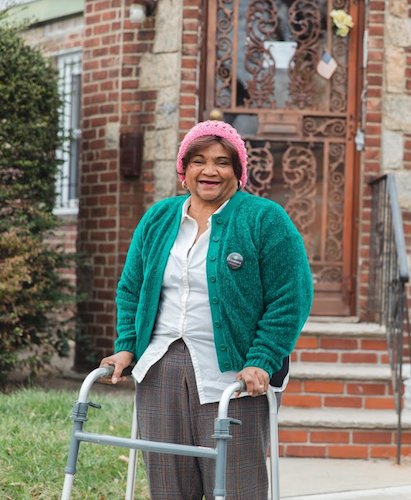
[177,120,247,188]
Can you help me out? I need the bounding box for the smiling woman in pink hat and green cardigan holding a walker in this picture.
[101,121,312,500]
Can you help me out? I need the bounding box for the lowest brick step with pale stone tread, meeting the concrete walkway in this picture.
[279,407,411,460]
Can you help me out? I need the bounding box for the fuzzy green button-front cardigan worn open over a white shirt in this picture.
[115,192,313,377]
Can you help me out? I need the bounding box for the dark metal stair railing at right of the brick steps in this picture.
[368,174,411,464]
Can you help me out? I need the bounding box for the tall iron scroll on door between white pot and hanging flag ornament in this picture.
[288,0,321,109]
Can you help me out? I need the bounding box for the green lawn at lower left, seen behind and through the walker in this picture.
[0,389,149,500]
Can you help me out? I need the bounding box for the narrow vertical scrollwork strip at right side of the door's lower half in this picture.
[325,144,346,262]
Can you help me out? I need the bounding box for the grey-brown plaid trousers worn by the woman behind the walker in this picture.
[136,340,280,500]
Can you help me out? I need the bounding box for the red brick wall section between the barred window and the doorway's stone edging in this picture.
[75,0,156,369]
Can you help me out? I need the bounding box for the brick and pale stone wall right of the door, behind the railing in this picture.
[358,0,411,320]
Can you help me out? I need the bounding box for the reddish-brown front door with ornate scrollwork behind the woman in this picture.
[203,0,360,315]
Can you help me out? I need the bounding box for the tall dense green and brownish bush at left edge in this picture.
[0,19,74,381]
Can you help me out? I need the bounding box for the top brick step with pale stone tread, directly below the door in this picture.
[291,320,389,364]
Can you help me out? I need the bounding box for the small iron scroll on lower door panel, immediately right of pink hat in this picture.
[245,141,274,197]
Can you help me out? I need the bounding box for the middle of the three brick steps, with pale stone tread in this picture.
[282,363,395,410]
